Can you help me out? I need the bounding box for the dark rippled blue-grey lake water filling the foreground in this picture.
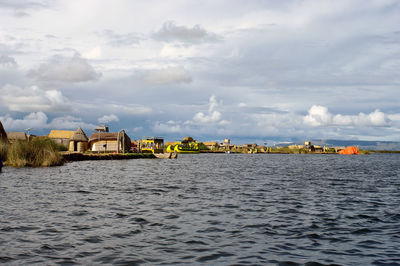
[0,154,400,265]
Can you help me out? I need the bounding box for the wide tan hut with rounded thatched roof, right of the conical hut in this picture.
[89,130,131,152]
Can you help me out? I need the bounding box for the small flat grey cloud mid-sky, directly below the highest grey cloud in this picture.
[140,67,192,85]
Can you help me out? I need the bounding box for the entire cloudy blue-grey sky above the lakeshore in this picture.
[0,0,400,143]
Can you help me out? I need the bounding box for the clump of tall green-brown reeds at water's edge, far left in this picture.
[6,138,63,167]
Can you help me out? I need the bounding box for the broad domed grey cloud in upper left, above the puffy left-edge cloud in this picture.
[28,53,101,84]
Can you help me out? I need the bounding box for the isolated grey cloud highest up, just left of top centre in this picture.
[153,21,218,43]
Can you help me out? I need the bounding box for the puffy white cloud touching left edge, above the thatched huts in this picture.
[0,84,71,112]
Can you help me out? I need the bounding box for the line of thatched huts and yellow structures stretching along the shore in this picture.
[0,122,345,153]
